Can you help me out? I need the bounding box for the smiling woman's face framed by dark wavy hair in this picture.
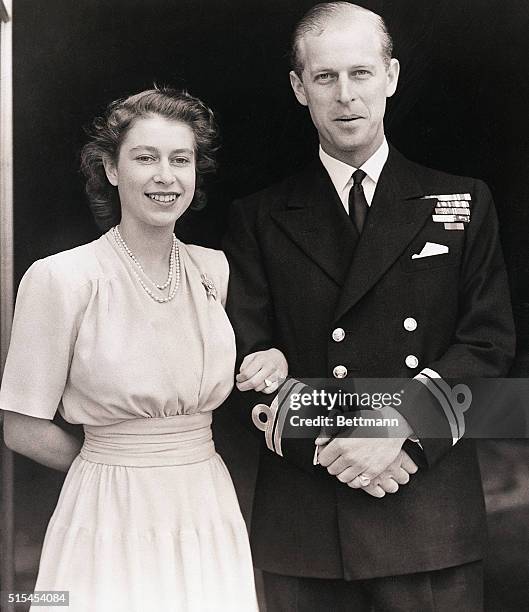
[105,115,195,227]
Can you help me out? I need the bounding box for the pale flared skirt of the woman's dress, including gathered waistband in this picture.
[34,412,257,612]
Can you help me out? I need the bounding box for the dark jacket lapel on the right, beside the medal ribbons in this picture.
[336,148,435,320]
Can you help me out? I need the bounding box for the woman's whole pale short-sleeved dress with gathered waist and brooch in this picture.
[0,233,257,612]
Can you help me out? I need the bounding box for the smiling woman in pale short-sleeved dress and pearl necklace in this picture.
[0,89,286,612]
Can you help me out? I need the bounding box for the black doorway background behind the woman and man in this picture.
[10,0,529,610]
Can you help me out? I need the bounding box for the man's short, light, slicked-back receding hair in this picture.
[290,2,393,78]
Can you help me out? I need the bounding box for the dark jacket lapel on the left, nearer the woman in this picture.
[272,160,358,286]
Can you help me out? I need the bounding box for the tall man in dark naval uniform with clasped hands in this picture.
[225,2,514,612]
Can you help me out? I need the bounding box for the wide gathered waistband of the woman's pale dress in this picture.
[80,412,215,467]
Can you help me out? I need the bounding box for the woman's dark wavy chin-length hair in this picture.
[81,87,218,231]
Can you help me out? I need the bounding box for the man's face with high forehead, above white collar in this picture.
[290,17,399,167]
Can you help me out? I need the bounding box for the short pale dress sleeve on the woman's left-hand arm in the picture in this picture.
[0,259,77,419]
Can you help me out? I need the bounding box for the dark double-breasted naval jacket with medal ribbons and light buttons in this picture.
[224,148,514,579]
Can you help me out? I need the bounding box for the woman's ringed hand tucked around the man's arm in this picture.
[235,348,288,393]
